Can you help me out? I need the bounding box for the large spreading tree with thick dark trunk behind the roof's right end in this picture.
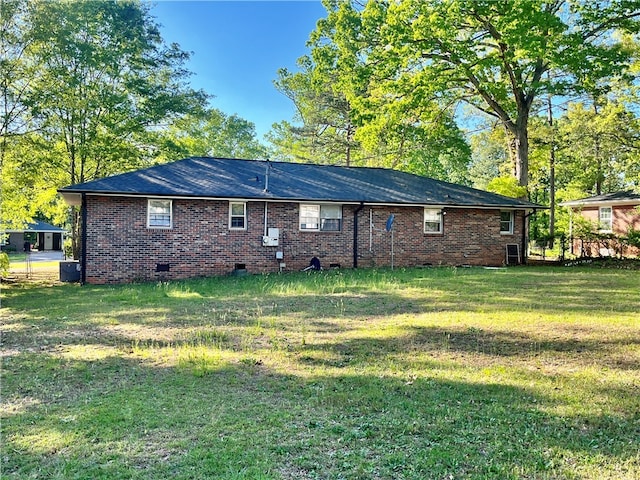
[315,0,640,186]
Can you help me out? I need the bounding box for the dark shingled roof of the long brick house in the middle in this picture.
[59,157,544,208]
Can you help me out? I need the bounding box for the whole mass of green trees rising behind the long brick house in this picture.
[0,0,640,251]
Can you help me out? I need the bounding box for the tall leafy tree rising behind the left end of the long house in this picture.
[2,0,205,255]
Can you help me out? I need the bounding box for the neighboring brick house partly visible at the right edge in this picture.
[560,191,640,256]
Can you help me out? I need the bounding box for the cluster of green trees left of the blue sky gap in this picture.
[0,0,263,255]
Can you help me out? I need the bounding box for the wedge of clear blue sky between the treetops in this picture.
[151,0,326,139]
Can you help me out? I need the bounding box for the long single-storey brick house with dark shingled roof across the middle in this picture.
[60,158,542,283]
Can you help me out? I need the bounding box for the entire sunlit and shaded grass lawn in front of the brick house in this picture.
[1,267,640,480]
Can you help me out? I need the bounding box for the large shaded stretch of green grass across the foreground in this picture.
[2,355,639,479]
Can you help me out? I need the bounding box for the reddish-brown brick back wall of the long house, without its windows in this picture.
[86,196,523,284]
